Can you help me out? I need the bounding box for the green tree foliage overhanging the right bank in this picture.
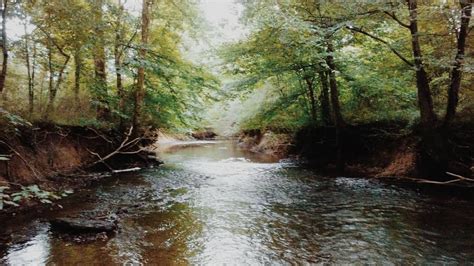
[216,0,472,133]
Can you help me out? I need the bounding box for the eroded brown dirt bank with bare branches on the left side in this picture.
[0,123,154,214]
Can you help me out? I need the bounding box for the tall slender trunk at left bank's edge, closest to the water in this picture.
[133,0,151,133]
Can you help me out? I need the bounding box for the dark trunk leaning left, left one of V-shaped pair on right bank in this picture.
[408,0,437,129]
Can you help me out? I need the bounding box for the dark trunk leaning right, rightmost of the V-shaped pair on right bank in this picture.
[444,0,472,126]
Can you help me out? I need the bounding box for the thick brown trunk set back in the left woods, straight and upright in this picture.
[93,0,110,120]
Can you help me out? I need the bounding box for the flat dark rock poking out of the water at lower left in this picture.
[50,218,117,234]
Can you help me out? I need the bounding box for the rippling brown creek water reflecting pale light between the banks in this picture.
[0,142,474,265]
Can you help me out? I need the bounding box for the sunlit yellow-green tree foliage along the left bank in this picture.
[0,0,219,132]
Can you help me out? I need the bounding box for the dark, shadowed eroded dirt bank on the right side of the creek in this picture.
[239,123,474,180]
